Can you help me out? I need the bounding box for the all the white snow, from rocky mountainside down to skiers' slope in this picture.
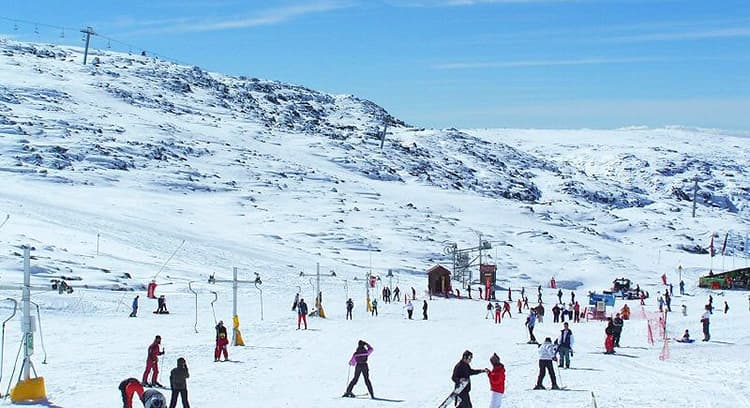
[0,41,750,408]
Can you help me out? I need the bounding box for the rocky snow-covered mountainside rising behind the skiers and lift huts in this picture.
[0,41,750,288]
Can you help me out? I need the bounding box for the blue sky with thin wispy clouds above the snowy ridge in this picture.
[0,0,750,130]
